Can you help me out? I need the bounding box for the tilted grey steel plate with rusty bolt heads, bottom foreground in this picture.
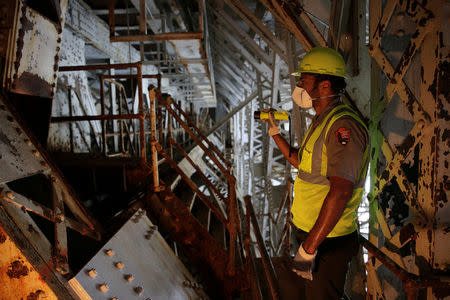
[70,209,207,300]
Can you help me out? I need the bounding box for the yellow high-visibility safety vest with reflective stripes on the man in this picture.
[291,104,369,237]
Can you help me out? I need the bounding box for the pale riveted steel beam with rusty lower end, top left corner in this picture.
[6,1,67,98]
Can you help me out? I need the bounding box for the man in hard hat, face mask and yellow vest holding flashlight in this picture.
[268,47,368,299]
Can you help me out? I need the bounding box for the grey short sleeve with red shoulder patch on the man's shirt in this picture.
[325,116,368,184]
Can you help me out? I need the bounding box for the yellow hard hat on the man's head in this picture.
[291,47,346,78]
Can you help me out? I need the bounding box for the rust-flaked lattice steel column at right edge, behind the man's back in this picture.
[367,0,450,299]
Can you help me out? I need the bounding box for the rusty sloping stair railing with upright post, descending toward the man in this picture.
[149,86,240,275]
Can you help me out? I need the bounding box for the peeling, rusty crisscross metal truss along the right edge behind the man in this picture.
[366,0,449,299]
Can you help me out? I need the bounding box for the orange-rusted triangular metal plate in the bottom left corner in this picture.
[0,226,58,300]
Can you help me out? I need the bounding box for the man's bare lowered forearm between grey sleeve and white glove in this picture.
[303,176,353,253]
